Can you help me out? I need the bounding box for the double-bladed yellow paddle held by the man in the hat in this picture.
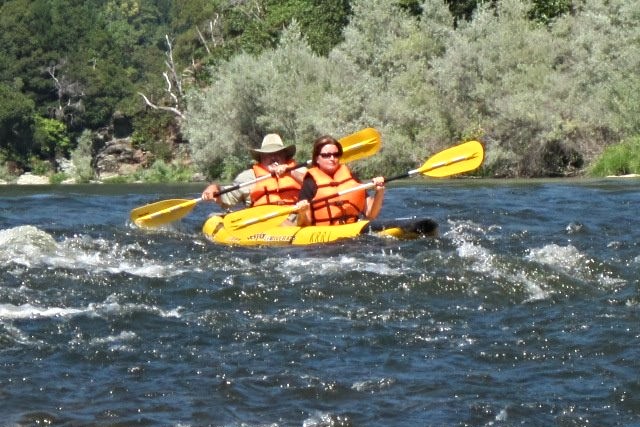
[129,128,381,228]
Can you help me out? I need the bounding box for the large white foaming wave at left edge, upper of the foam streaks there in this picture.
[0,225,186,278]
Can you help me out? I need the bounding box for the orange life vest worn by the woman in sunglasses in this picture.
[307,165,367,225]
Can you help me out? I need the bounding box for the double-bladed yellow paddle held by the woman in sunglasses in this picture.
[224,141,484,237]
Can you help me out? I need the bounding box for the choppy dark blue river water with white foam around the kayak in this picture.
[0,179,640,427]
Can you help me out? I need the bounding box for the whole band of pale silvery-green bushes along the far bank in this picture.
[179,0,640,176]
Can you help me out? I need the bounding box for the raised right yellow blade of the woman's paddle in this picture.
[418,141,484,178]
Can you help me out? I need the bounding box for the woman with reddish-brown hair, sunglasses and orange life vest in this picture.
[297,136,384,226]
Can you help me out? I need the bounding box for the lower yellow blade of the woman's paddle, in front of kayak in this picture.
[223,205,296,236]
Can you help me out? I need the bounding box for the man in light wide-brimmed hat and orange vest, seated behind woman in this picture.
[202,133,306,209]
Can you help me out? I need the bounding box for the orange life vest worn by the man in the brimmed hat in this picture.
[251,161,301,206]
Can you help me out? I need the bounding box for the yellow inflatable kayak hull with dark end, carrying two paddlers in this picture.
[202,215,438,246]
